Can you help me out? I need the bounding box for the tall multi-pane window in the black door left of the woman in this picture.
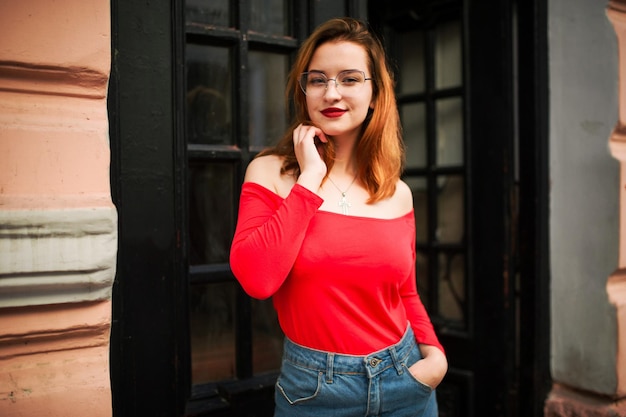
[184,0,297,396]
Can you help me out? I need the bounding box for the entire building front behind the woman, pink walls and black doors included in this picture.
[0,0,626,417]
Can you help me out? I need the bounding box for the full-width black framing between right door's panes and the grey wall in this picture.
[465,0,551,416]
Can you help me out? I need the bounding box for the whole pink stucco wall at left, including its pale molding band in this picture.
[0,0,117,417]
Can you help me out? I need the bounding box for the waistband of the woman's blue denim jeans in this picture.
[283,326,416,380]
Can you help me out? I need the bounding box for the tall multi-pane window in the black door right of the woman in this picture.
[391,15,467,329]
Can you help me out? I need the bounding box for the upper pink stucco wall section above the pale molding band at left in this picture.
[0,0,110,208]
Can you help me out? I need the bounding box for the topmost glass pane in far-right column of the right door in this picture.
[435,21,462,88]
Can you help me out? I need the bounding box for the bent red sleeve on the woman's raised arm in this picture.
[230,182,323,299]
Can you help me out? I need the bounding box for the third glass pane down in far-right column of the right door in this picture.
[437,176,464,243]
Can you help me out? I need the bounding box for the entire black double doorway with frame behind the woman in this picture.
[109,0,548,417]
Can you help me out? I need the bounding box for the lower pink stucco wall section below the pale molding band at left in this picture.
[0,301,112,417]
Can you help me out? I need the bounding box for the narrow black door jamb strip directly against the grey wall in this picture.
[514,0,552,416]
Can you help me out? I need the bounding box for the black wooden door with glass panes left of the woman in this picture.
[109,0,365,417]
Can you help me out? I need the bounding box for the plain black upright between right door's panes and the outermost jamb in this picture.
[465,0,517,416]
